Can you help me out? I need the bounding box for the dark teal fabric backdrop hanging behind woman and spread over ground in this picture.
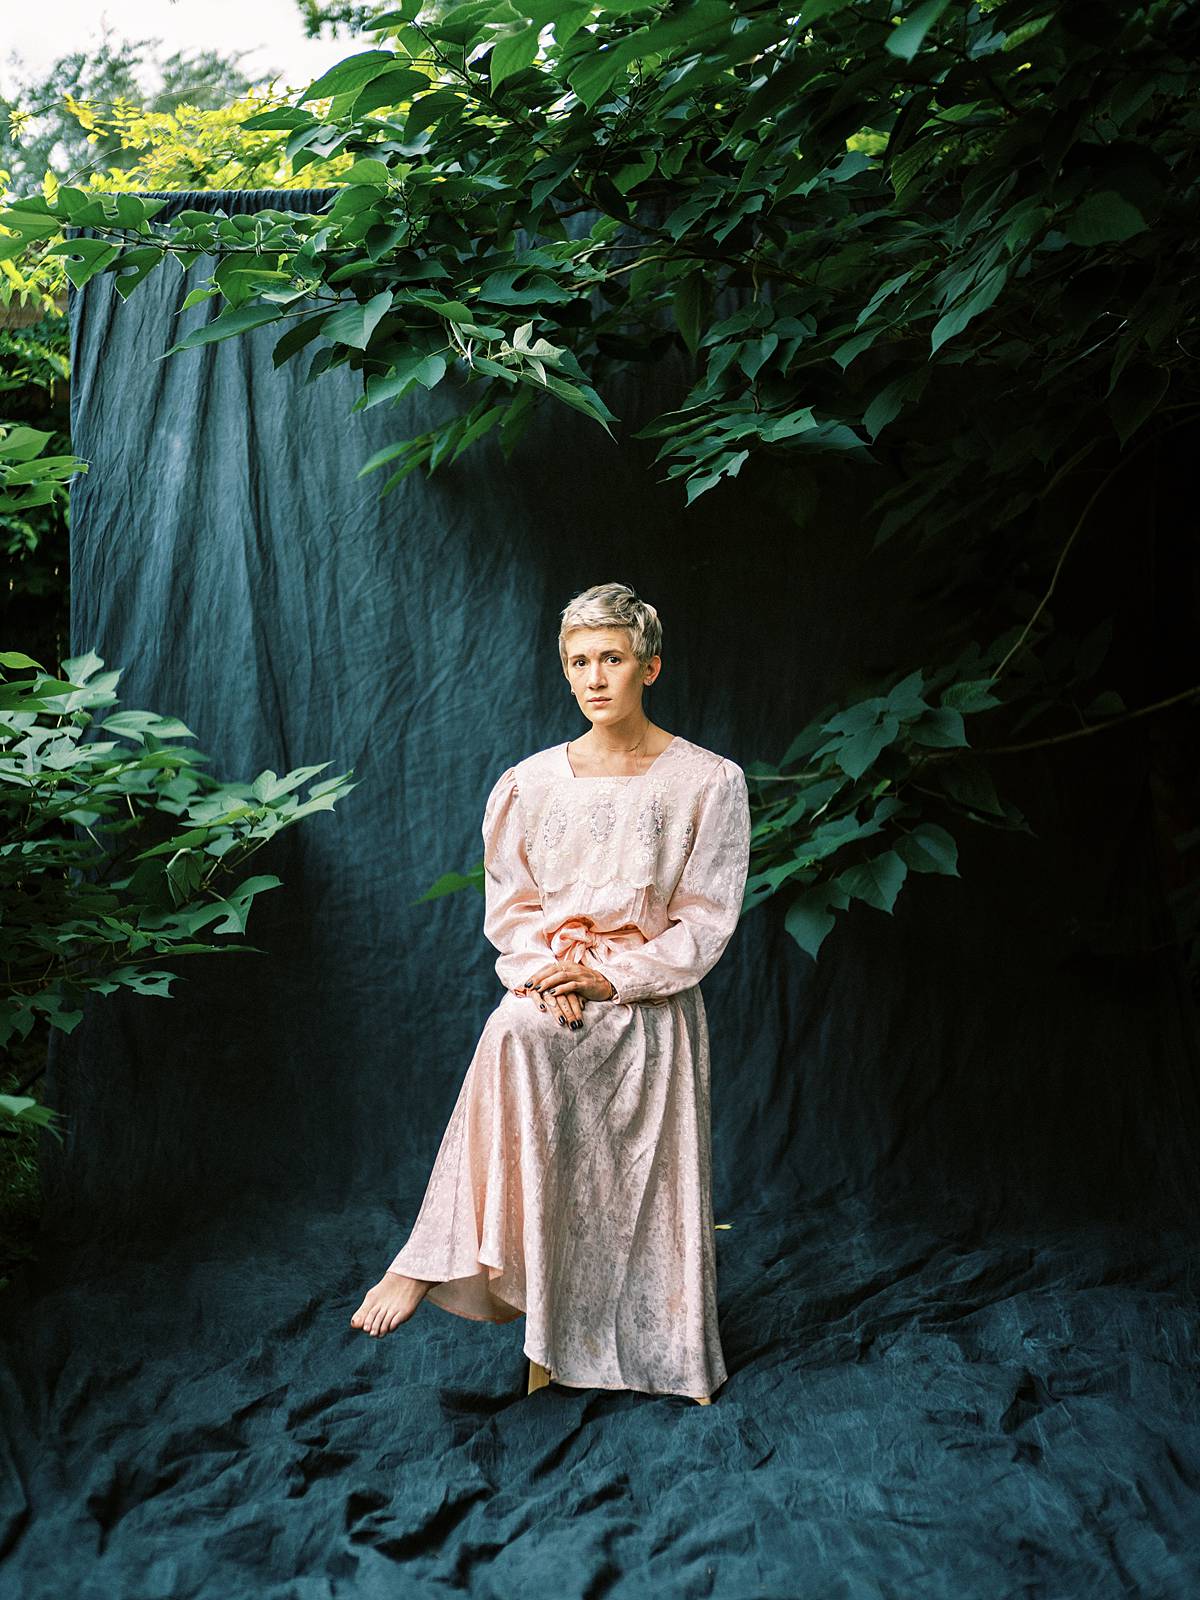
[0,192,1200,1600]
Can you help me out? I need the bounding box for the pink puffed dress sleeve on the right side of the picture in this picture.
[594,758,750,1003]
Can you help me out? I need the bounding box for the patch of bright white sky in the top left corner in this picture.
[0,0,350,93]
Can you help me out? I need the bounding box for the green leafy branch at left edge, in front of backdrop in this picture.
[0,651,355,1120]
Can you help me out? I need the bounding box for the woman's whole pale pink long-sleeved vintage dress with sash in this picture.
[390,734,750,1398]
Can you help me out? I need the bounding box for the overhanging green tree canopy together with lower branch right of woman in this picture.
[0,0,1200,950]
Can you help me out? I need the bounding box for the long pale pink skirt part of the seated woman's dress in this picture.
[390,987,726,1398]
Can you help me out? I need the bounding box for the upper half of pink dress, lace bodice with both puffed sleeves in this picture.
[483,736,750,1003]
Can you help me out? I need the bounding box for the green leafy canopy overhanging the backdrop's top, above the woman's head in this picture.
[0,0,1195,505]
